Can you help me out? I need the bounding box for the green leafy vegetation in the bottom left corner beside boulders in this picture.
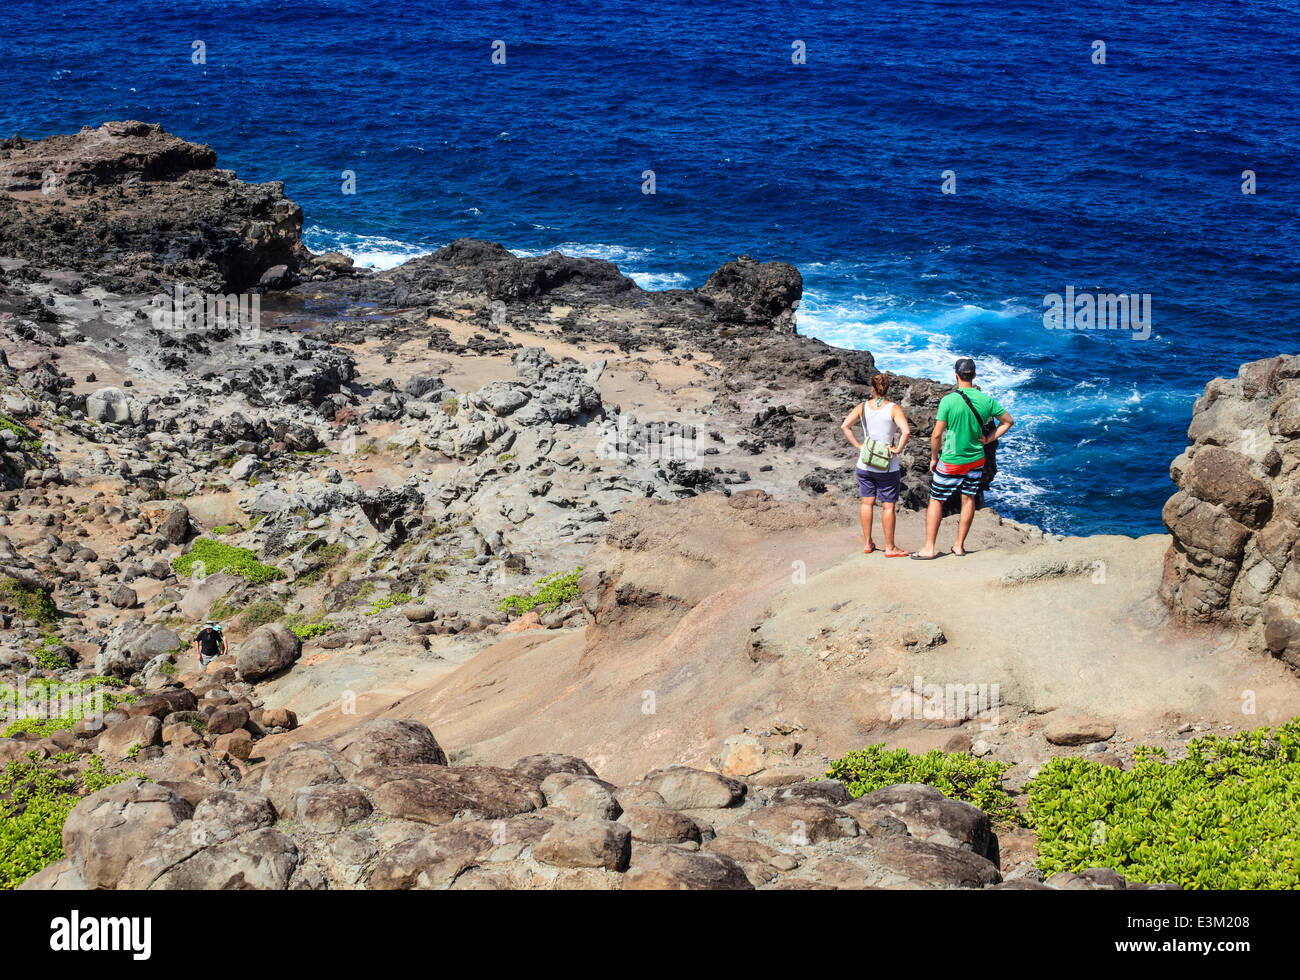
[0,753,139,890]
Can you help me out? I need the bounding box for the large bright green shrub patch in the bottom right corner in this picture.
[1030,719,1300,889]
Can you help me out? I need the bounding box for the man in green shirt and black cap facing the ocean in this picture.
[913,357,1015,561]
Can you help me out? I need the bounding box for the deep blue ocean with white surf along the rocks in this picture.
[0,0,1300,534]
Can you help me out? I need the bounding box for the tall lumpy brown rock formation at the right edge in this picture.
[1161,356,1300,671]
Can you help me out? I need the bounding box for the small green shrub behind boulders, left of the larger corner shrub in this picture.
[826,742,1024,825]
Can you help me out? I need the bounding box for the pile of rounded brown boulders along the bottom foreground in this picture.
[31,720,1180,890]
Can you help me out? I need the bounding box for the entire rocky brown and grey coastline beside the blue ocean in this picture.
[0,121,1300,889]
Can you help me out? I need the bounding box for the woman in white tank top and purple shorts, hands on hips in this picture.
[840,374,911,558]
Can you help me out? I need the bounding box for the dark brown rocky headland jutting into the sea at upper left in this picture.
[0,121,309,291]
